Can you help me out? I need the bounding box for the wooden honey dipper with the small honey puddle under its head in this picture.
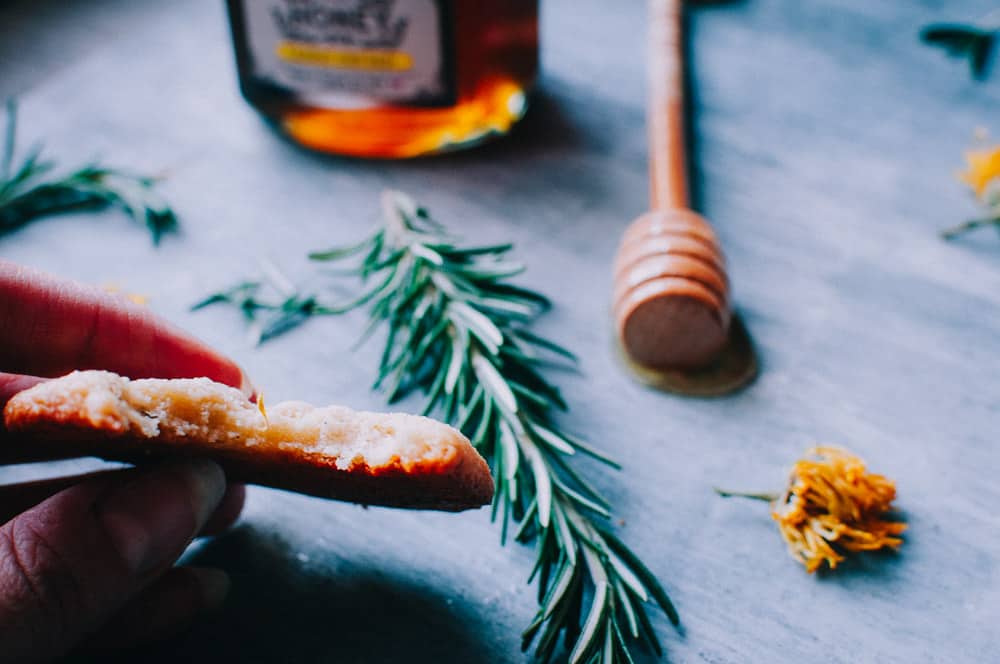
[613,0,757,394]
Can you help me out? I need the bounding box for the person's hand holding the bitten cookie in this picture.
[0,261,250,662]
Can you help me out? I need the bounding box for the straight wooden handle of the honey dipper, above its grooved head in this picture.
[647,0,690,210]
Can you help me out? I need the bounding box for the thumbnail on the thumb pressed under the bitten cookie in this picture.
[97,460,226,576]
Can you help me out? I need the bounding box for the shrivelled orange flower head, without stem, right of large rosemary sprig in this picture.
[771,447,906,573]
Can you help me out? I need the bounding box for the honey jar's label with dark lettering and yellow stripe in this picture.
[243,0,456,108]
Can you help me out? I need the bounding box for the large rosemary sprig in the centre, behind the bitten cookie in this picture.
[202,191,679,664]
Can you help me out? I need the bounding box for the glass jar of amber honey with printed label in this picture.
[227,0,538,158]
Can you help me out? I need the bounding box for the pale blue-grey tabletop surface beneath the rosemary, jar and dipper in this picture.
[0,0,1000,663]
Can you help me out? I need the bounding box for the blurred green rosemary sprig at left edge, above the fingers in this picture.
[0,100,177,244]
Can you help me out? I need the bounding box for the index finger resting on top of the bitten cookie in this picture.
[0,260,252,395]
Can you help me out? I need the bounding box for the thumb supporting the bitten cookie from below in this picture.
[0,461,226,662]
